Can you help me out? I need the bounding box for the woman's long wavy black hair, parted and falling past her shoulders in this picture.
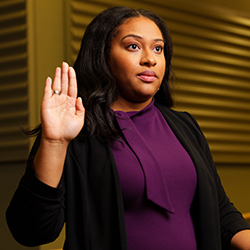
[74,6,173,138]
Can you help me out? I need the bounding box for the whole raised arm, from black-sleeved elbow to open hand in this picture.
[6,63,84,246]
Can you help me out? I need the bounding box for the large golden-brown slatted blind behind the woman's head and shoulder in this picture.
[68,0,250,164]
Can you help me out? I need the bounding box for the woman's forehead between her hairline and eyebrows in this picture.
[117,16,162,39]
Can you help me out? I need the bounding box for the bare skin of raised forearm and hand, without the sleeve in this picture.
[33,63,84,187]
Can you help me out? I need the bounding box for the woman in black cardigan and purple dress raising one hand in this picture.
[7,7,250,250]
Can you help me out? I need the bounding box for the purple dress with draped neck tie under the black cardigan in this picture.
[110,102,197,250]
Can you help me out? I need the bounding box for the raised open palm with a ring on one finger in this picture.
[41,63,85,142]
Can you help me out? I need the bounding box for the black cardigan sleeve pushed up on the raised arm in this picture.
[6,136,64,246]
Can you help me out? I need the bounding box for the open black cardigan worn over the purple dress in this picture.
[6,104,250,250]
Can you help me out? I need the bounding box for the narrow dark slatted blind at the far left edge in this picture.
[0,0,28,162]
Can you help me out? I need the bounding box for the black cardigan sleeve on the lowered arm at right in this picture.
[186,113,250,249]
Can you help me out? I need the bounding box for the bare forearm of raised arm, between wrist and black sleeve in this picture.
[33,139,68,187]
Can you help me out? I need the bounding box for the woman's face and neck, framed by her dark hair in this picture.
[109,17,166,111]
